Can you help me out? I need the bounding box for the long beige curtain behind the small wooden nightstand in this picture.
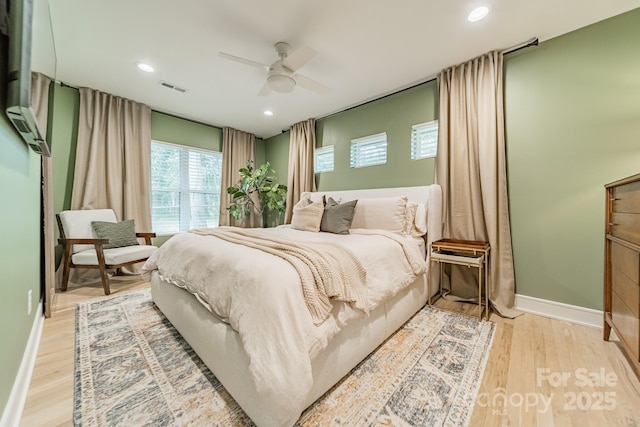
[435,52,521,317]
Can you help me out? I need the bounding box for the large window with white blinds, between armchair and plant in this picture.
[151,141,222,234]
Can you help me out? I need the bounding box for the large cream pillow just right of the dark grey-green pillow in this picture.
[351,197,407,234]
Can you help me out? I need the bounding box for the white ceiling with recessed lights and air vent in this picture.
[41,0,640,138]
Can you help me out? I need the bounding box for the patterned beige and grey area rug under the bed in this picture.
[73,290,495,427]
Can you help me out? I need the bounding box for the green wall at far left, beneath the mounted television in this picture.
[0,35,42,415]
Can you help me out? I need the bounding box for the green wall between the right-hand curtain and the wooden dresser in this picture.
[505,9,640,310]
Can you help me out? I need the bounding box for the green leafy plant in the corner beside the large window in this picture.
[227,160,287,220]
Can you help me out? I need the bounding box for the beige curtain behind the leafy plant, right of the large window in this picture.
[219,127,262,227]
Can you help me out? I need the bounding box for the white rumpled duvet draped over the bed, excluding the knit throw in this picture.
[142,226,426,425]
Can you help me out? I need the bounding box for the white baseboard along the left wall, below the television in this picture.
[0,301,44,427]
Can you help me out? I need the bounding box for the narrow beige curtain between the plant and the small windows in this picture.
[284,119,316,224]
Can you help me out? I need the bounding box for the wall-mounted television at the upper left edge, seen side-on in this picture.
[0,0,51,156]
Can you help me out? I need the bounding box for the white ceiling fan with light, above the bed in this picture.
[219,42,331,96]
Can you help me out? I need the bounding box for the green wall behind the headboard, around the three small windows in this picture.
[266,80,438,191]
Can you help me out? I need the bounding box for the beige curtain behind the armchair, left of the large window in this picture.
[71,88,151,231]
